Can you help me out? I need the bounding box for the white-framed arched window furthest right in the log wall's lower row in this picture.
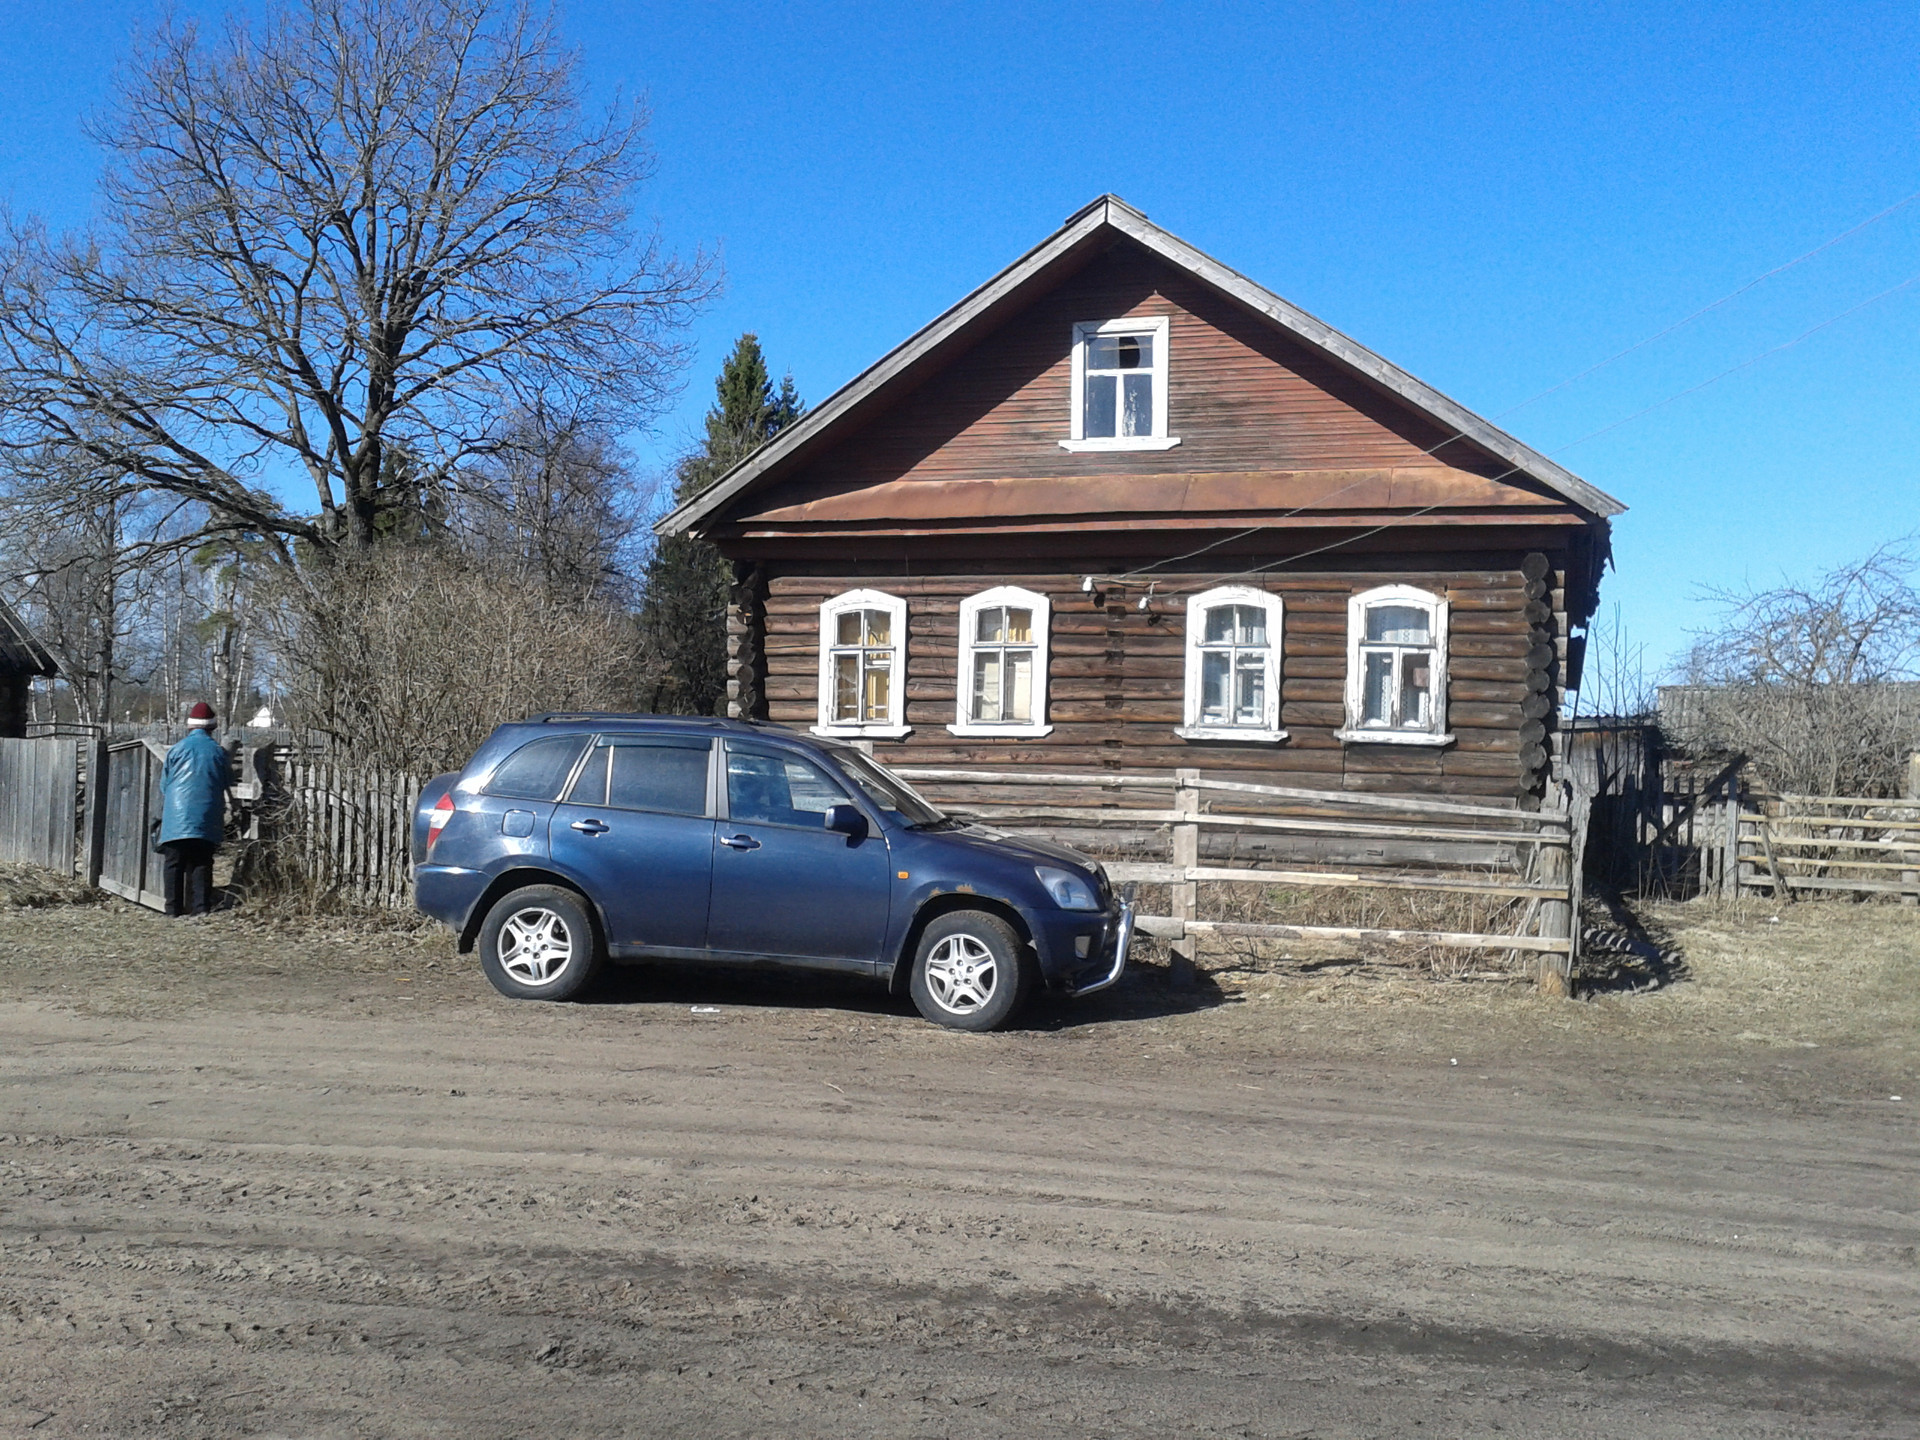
[1340,586,1453,745]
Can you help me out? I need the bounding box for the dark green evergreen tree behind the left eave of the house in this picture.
[639,334,804,714]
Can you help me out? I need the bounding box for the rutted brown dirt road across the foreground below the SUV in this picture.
[0,906,1920,1440]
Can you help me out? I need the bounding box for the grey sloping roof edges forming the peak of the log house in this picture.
[655,196,1626,536]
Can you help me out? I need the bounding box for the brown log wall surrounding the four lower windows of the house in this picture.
[760,553,1567,801]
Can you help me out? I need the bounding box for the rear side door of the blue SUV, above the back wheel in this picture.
[549,735,714,956]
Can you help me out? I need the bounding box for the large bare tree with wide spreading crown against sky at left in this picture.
[0,0,716,557]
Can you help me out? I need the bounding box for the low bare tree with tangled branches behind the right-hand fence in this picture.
[1663,540,1920,795]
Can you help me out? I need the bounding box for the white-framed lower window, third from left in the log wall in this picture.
[1175,586,1286,743]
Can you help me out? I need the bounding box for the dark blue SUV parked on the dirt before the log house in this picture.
[413,714,1133,1031]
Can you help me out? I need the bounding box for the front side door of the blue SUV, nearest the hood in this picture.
[707,739,893,972]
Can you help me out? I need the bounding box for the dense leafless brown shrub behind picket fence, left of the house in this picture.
[273,543,647,774]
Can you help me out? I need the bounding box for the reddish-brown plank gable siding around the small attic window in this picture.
[730,244,1565,524]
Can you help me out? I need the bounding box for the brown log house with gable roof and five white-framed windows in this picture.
[659,196,1624,804]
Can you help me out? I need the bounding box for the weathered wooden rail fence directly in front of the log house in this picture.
[899,766,1578,995]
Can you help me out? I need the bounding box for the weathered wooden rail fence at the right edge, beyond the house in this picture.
[1738,795,1920,904]
